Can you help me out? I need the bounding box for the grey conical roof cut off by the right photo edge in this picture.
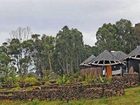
[127,46,140,59]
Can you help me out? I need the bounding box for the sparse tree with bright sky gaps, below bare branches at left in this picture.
[8,39,33,76]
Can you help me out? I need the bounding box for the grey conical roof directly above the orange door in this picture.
[91,50,121,66]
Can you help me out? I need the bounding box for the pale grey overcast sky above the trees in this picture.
[0,0,140,45]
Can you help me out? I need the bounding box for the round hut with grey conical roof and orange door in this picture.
[91,50,123,76]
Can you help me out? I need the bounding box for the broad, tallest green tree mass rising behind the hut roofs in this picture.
[96,19,138,53]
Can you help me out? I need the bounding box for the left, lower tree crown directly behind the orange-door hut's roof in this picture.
[96,23,119,52]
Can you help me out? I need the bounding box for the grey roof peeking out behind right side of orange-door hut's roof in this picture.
[111,51,127,61]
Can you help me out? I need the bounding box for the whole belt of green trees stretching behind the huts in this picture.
[0,19,140,84]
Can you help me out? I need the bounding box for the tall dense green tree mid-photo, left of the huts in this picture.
[55,26,84,74]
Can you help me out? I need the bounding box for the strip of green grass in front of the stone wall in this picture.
[0,87,140,105]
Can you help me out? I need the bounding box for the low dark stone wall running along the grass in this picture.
[0,74,139,100]
